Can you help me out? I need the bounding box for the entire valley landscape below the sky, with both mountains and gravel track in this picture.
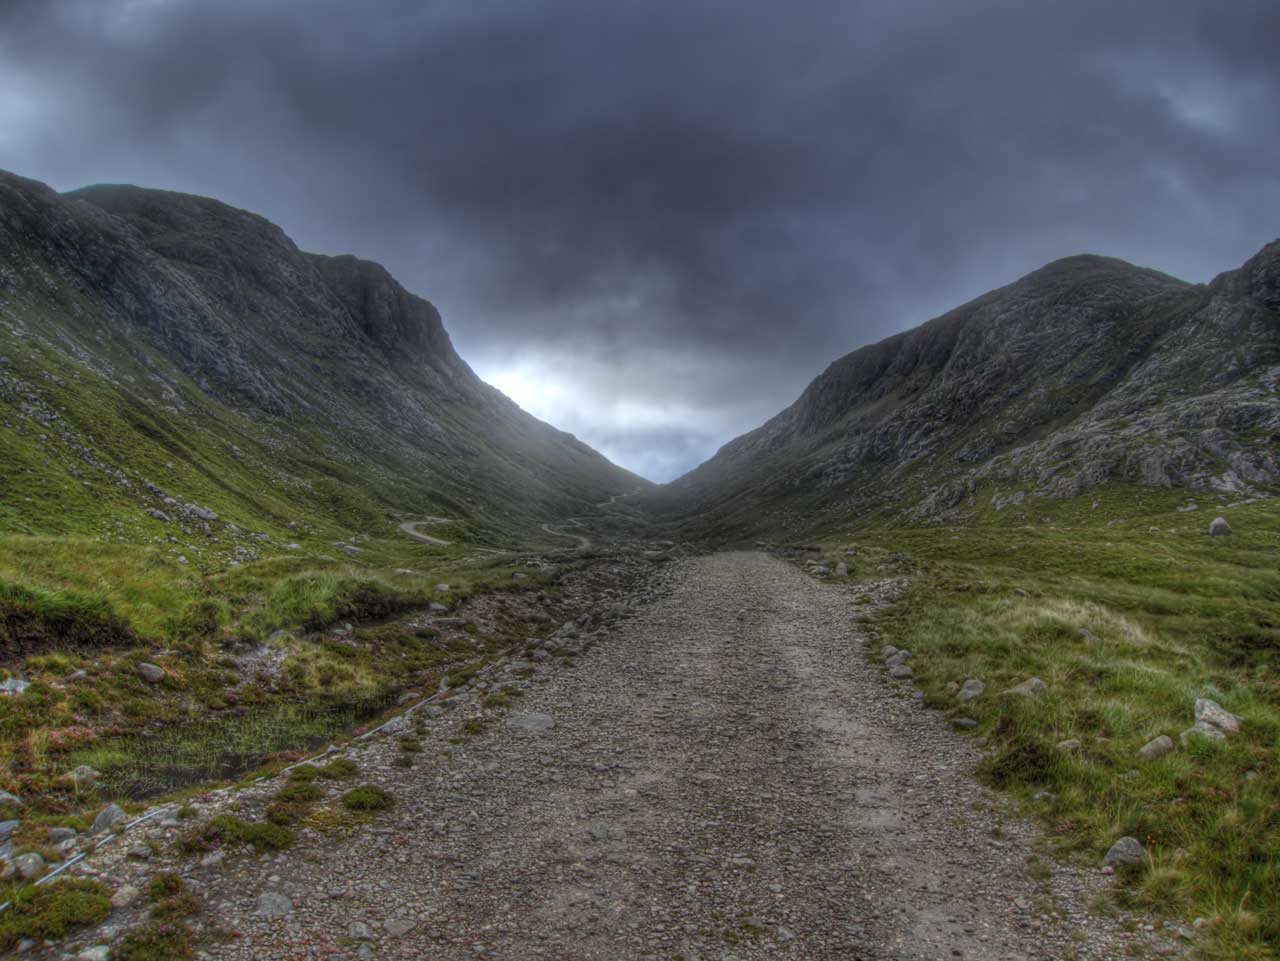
[0,167,1280,961]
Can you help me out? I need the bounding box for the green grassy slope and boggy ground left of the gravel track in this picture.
[0,272,609,809]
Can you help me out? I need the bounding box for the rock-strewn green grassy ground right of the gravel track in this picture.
[783,488,1280,958]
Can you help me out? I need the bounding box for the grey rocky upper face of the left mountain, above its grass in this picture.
[0,173,641,545]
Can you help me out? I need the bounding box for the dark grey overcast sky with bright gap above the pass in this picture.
[0,0,1280,480]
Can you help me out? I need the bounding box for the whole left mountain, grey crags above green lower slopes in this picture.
[0,173,644,566]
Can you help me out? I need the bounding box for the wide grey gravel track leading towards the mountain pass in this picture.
[77,554,1172,961]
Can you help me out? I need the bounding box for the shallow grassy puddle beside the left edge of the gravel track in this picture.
[70,692,396,801]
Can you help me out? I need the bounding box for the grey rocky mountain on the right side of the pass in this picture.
[658,242,1280,535]
